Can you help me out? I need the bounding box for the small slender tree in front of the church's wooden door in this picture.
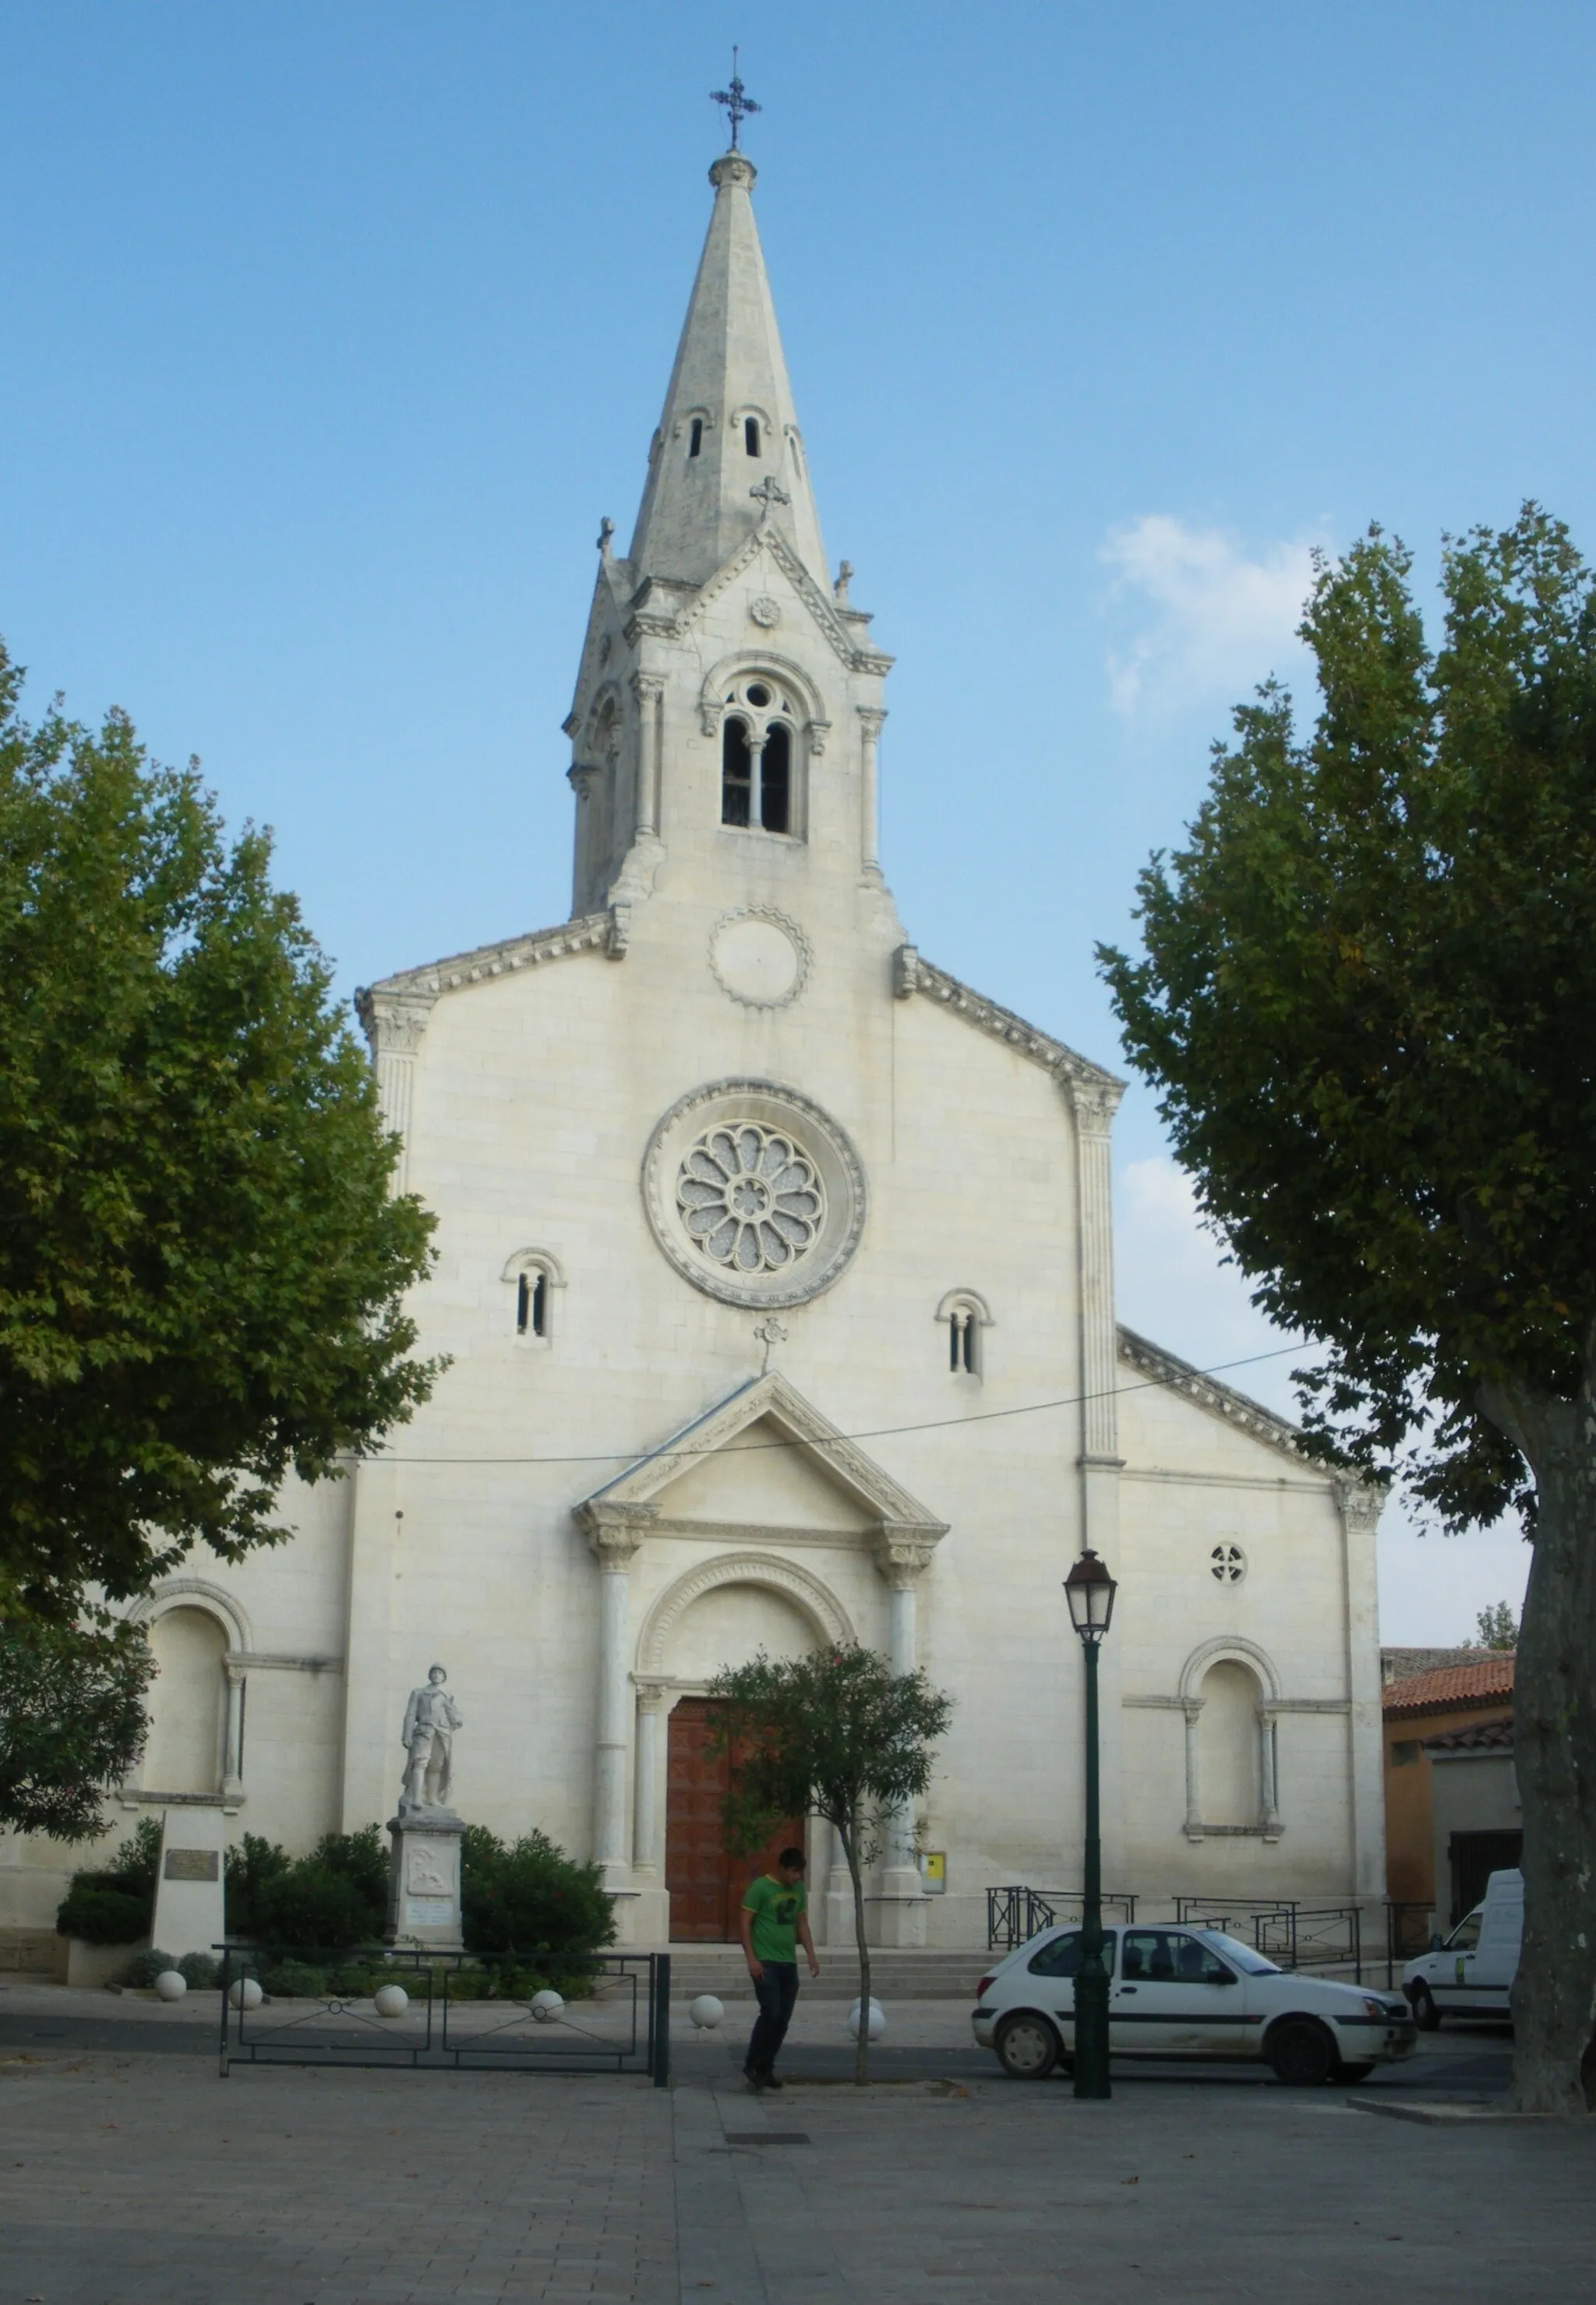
[711,1646,952,2086]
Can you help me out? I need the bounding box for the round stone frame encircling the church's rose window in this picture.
[641,1078,867,1311]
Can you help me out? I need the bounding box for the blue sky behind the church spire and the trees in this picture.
[0,0,1596,1641]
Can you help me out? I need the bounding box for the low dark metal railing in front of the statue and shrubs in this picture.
[217,1943,671,2088]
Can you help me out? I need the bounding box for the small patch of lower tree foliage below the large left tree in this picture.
[0,1618,154,1841]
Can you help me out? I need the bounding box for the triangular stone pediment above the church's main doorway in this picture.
[577,1369,948,1544]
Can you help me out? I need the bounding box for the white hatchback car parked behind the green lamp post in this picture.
[971,1922,1418,2086]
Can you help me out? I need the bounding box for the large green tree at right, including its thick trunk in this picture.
[1100,505,1596,2112]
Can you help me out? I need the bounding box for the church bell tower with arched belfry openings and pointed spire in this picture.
[565,143,892,943]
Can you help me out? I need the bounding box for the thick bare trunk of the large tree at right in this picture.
[1481,1355,1596,2113]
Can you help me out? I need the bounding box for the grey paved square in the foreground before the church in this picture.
[0,2010,1596,2305]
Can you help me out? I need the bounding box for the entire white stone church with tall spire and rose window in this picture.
[0,139,1384,1946]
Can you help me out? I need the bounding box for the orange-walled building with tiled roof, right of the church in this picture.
[1384,1650,1517,1918]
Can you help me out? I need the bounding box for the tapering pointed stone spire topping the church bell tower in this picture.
[627,152,826,583]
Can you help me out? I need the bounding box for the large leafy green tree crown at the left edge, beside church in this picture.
[0,650,436,1627]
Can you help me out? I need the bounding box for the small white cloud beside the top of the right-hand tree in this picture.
[1100,512,1312,715]
